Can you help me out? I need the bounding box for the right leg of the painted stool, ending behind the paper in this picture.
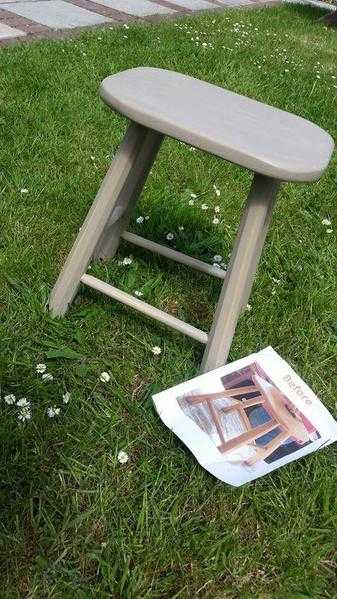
[201,174,280,372]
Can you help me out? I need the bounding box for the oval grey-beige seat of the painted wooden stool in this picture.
[100,67,334,181]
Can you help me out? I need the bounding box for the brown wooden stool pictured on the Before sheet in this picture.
[184,374,310,466]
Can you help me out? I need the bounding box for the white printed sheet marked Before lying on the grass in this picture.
[153,347,337,486]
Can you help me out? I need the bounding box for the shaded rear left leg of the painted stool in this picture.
[93,129,163,261]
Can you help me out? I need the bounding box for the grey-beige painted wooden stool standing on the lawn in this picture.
[50,67,334,372]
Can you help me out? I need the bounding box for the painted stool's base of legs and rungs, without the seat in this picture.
[49,121,280,372]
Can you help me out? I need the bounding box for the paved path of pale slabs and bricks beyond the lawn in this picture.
[0,0,278,45]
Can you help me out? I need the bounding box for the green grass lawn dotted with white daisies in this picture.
[0,7,337,599]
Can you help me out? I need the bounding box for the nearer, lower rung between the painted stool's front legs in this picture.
[81,274,208,343]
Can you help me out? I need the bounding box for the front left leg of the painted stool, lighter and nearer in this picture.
[49,123,159,316]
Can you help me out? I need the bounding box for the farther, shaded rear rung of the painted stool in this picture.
[122,231,226,279]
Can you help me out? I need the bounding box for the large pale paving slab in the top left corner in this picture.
[1,0,113,29]
